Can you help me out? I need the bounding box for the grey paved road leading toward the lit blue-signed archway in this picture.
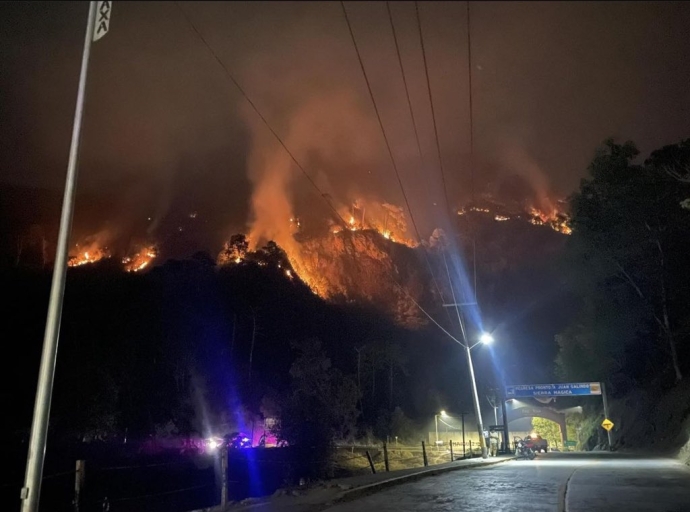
[328,452,690,512]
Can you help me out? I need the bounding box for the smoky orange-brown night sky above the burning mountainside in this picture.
[0,2,690,253]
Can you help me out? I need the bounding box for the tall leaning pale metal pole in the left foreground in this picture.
[20,2,97,512]
